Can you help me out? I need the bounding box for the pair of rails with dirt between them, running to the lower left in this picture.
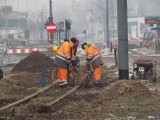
[0,81,80,112]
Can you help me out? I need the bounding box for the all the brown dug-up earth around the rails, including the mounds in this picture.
[0,52,160,120]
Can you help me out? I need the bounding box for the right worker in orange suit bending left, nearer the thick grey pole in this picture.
[82,42,103,87]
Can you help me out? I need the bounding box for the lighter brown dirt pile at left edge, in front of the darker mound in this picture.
[0,72,40,107]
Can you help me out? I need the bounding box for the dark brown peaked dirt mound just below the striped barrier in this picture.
[12,51,53,79]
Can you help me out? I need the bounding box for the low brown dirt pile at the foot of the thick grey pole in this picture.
[104,80,152,99]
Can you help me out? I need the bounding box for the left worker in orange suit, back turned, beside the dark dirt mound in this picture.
[54,39,76,88]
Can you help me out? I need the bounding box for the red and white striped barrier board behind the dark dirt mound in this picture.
[7,48,48,54]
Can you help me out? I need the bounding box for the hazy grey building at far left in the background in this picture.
[0,6,28,39]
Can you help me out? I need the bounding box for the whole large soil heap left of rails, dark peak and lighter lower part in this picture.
[0,52,53,105]
